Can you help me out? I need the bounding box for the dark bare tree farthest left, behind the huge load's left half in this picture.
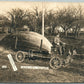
[8,9,26,31]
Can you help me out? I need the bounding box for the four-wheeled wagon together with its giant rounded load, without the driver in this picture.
[2,31,72,69]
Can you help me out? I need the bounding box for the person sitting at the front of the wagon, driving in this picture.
[54,34,65,55]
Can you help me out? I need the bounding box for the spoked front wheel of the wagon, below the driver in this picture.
[50,57,61,69]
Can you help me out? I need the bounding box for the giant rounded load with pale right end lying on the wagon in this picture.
[2,31,52,53]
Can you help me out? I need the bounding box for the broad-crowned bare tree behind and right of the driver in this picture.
[57,7,75,36]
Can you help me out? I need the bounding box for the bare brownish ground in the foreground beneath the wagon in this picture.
[0,33,84,83]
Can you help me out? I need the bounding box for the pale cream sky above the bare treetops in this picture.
[0,1,84,14]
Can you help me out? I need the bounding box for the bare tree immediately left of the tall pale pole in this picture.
[25,6,42,33]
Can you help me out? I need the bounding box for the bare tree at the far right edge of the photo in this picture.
[73,5,84,37]
